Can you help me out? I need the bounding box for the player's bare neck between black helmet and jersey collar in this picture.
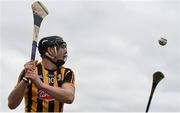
[42,59,57,70]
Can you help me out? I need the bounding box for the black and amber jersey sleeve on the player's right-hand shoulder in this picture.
[63,69,75,86]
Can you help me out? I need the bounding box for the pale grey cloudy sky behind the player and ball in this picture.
[0,0,180,112]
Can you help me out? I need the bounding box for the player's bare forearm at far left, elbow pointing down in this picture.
[8,81,27,109]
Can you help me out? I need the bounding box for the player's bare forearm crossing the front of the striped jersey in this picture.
[42,84,74,104]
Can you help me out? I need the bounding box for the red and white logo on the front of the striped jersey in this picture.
[38,90,54,101]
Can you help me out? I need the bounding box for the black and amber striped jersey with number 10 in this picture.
[25,62,75,112]
